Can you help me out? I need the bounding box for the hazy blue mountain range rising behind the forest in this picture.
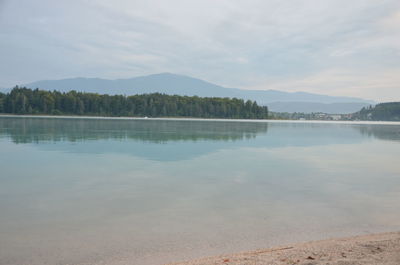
[14,73,374,113]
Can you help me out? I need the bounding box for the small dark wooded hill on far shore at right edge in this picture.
[352,102,400,121]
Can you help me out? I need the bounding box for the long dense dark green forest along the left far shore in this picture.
[0,87,268,119]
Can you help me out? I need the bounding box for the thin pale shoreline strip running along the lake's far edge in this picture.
[0,113,400,125]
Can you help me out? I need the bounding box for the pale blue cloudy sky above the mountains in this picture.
[0,0,400,102]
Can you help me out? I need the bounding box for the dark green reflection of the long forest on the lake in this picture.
[0,117,268,143]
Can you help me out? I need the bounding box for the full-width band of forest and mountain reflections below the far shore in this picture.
[0,117,400,161]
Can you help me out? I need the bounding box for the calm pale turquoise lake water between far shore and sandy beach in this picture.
[0,117,400,265]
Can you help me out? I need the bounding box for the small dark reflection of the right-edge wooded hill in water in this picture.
[355,125,400,141]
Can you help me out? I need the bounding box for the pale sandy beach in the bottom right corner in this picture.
[170,232,400,265]
